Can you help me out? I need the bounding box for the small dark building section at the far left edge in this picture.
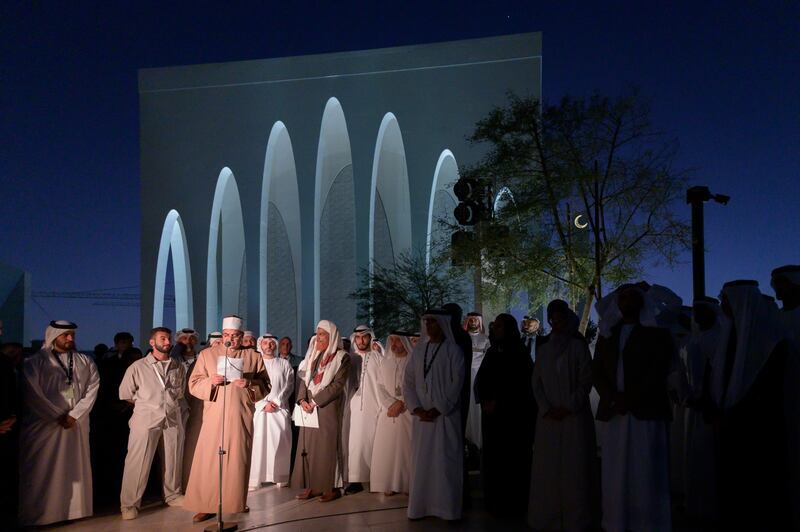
[0,262,31,345]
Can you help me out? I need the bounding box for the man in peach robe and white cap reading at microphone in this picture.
[183,316,269,522]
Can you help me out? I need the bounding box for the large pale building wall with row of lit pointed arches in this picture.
[139,33,542,345]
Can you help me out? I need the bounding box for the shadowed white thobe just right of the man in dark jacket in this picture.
[673,326,720,520]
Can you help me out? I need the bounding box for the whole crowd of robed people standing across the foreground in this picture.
[0,266,800,532]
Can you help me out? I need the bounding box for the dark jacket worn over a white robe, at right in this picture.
[592,323,675,421]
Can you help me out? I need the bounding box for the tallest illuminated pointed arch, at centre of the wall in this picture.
[314,98,356,327]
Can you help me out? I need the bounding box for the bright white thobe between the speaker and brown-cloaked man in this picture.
[248,357,294,489]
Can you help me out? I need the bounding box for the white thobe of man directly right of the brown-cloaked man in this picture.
[347,351,382,482]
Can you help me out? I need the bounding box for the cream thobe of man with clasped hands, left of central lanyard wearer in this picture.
[369,352,412,493]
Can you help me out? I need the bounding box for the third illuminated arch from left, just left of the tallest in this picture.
[259,121,302,345]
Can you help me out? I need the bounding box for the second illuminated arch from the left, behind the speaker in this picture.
[206,167,247,332]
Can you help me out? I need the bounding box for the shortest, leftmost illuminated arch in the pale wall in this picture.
[153,209,194,329]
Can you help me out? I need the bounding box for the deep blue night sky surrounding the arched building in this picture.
[0,1,800,349]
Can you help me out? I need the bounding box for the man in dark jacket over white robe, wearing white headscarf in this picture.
[592,285,680,532]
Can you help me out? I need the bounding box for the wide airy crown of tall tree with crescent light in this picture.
[462,91,689,332]
